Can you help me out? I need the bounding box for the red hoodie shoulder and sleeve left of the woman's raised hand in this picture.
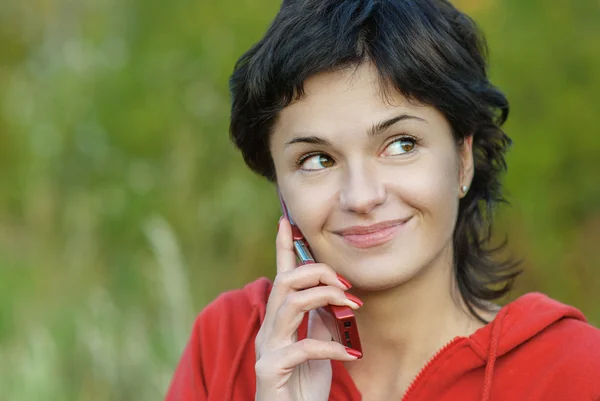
[166,278,272,401]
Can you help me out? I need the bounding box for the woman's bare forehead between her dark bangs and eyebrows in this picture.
[275,64,443,136]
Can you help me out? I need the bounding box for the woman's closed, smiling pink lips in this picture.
[335,216,412,248]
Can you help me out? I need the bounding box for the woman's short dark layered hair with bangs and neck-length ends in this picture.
[230,0,520,322]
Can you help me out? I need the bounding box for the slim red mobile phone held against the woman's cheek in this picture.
[277,189,362,352]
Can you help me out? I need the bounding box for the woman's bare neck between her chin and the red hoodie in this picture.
[355,246,490,373]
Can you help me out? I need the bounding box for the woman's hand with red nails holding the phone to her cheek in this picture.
[255,218,360,401]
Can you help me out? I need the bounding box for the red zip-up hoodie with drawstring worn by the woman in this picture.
[166,278,600,401]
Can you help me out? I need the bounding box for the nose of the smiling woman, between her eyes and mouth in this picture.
[340,161,387,214]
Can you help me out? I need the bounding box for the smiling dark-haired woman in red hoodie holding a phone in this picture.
[167,0,600,401]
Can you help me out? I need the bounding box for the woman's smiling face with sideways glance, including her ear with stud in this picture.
[270,64,472,290]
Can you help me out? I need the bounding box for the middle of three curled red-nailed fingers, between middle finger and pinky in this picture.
[270,286,360,343]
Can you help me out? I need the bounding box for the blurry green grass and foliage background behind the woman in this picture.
[0,0,600,401]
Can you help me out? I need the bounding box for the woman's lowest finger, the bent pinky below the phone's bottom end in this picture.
[255,338,358,377]
